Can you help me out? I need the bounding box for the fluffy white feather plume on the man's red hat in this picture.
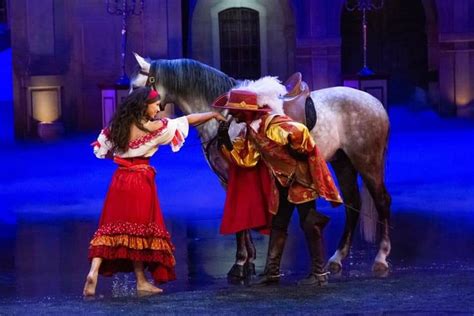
[234,76,286,115]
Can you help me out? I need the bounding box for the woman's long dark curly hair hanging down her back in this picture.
[109,87,151,152]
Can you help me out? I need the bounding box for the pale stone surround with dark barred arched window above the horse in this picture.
[188,0,296,80]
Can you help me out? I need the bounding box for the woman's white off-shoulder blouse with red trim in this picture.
[92,116,189,159]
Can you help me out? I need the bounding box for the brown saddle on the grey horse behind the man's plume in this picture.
[283,72,317,130]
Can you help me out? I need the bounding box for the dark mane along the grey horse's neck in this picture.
[156,59,235,103]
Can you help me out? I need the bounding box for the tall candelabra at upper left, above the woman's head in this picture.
[107,0,145,85]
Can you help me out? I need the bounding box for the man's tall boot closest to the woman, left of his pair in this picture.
[257,229,288,284]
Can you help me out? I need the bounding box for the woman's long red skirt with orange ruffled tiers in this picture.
[89,158,176,283]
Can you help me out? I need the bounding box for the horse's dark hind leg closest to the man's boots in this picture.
[328,150,361,273]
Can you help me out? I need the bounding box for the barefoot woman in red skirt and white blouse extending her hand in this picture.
[83,87,225,296]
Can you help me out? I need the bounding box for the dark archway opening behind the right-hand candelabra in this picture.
[341,0,433,104]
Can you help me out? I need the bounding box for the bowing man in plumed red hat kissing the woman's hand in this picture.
[214,77,342,286]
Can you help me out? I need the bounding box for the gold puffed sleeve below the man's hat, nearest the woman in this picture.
[221,137,260,168]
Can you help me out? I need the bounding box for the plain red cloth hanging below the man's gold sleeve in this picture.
[220,161,272,234]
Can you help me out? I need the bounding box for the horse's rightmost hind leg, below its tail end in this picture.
[362,173,391,275]
